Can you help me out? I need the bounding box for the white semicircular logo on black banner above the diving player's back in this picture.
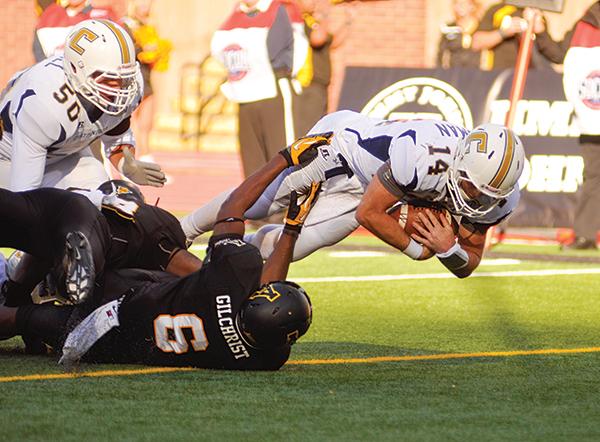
[361,77,473,129]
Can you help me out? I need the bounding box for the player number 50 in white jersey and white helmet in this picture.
[0,20,165,191]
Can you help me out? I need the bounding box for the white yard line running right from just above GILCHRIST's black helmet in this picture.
[291,267,600,283]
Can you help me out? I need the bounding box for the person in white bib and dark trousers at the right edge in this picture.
[525,1,600,249]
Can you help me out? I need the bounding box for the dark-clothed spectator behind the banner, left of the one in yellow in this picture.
[437,0,481,69]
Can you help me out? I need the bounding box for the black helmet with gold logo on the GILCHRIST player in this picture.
[237,281,312,349]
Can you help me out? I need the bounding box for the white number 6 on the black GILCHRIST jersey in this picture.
[154,314,208,354]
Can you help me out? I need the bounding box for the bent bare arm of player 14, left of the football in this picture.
[356,163,433,260]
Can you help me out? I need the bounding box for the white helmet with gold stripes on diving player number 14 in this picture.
[447,123,525,218]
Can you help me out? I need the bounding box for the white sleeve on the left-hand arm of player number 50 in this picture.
[9,98,59,192]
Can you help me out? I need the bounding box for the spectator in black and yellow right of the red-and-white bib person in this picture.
[295,0,352,135]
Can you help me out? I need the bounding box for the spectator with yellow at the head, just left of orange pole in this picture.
[471,3,527,70]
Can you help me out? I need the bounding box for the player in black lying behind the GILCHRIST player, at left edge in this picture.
[0,180,202,307]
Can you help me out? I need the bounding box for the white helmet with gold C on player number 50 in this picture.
[63,20,140,115]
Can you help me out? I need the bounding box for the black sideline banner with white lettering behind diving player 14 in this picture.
[338,67,583,227]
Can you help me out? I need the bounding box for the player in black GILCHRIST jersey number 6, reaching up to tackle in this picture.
[0,138,320,370]
